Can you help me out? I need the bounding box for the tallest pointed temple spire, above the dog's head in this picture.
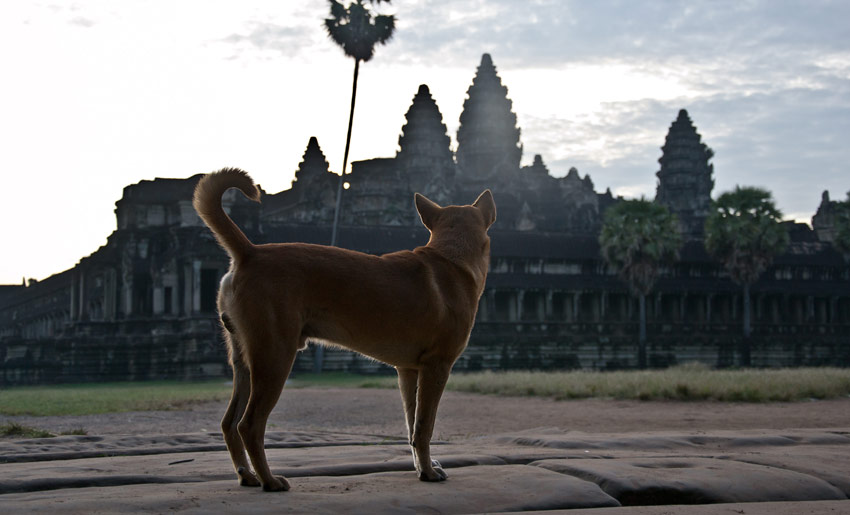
[457,54,522,180]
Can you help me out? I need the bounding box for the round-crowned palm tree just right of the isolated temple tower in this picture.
[705,186,788,366]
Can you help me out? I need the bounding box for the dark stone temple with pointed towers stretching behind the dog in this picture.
[0,54,850,384]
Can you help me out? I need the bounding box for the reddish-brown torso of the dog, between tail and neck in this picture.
[232,243,480,366]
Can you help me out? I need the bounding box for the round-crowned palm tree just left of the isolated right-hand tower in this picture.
[599,198,682,368]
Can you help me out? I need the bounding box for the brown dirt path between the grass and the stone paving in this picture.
[6,388,850,440]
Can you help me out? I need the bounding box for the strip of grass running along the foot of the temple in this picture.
[0,364,850,416]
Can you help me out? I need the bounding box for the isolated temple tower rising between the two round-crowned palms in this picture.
[655,109,714,240]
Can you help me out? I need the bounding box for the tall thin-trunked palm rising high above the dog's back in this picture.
[313,0,395,373]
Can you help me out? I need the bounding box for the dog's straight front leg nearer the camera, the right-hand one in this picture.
[410,363,451,481]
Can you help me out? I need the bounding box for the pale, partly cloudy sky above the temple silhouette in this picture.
[0,0,850,284]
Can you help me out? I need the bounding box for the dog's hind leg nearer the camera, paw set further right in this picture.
[236,330,298,492]
